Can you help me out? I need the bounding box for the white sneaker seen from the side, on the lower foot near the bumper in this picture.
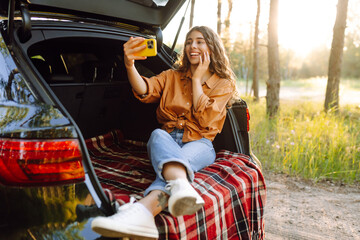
[91,199,159,239]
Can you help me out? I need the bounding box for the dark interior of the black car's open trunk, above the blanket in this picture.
[25,24,250,156]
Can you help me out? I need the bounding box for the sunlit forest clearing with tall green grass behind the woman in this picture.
[164,0,360,184]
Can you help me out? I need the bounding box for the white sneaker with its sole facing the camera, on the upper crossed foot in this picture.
[166,178,204,217]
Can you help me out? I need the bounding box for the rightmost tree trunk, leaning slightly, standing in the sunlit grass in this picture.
[324,0,348,111]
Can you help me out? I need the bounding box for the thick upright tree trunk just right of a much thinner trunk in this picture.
[266,0,280,117]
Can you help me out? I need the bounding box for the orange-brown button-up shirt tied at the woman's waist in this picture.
[134,69,233,142]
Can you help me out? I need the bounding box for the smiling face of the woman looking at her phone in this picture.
[185,30,210,65]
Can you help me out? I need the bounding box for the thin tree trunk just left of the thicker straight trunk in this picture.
[252,0,260,101]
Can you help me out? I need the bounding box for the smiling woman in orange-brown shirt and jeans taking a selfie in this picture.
[92,26,236,239]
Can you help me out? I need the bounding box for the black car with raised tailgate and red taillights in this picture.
[0,0,265,239]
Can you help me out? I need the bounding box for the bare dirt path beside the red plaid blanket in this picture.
[264,172,360,240]
